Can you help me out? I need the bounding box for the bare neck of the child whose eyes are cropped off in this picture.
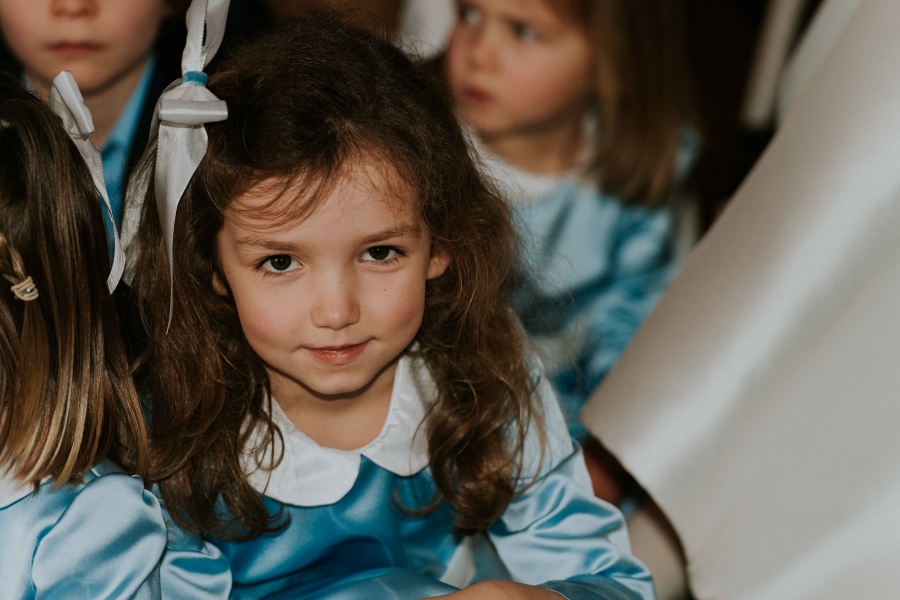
[27,55,150,148]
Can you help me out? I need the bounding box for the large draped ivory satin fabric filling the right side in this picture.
[582,0,900,600]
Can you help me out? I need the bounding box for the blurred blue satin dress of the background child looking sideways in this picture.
[474,132,699,440]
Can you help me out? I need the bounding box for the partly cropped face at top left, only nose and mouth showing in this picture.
[0,0,168,95]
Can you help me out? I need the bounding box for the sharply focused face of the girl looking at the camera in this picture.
[218,161,449,397]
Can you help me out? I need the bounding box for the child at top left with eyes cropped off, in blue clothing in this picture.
[0,0,185,250]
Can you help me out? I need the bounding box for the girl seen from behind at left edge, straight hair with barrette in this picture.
[0,74,166,599]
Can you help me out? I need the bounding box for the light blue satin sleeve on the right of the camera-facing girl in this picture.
[488,372,655,600]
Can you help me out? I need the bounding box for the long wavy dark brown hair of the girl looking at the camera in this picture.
[134,13,544,539]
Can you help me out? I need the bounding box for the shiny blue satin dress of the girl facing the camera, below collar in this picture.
[162,446,654,600]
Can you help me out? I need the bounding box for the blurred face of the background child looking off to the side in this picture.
[446,0,593,136]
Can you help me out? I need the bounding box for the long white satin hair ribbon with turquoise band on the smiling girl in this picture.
[153,0,229,323]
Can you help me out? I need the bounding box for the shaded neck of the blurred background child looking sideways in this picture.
[481,115,584,175]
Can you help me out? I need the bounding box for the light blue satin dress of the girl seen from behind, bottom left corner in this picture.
[0,460,166,600]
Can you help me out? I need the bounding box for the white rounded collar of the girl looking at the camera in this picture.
[244,356,436,506]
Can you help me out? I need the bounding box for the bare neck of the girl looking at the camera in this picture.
[269,358,399,450]
